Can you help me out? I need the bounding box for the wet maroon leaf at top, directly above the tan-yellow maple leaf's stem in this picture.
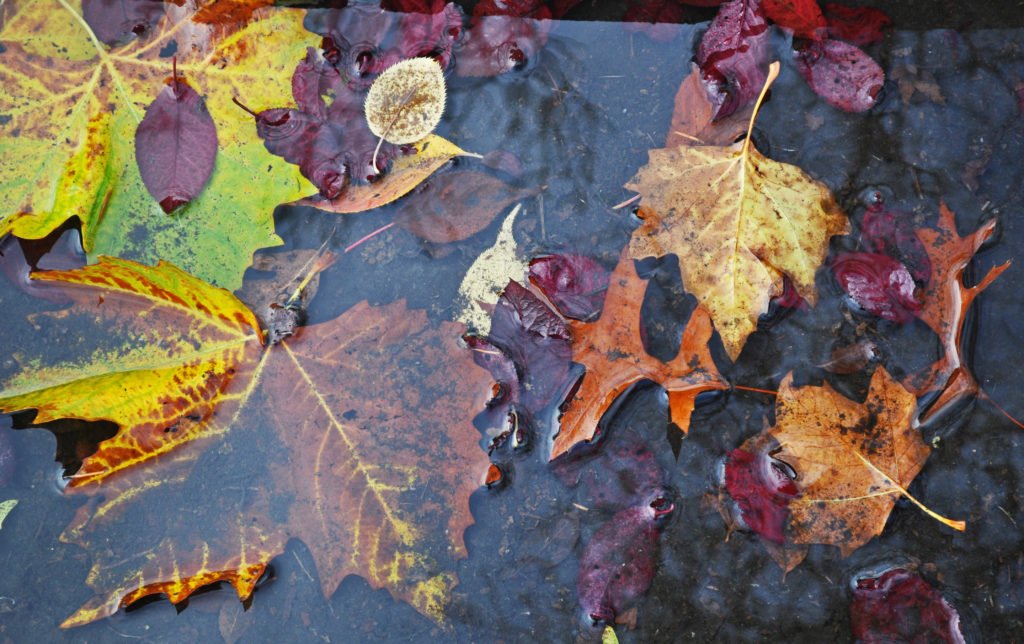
[697,0,768,119]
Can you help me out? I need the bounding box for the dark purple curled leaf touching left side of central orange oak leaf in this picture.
[487,282,572,412]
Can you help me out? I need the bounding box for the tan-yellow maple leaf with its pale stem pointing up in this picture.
[626,63,849,359]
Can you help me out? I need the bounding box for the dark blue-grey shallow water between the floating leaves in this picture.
[0,2,1024,642]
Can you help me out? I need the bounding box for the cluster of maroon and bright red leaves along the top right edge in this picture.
[696,0,888,119]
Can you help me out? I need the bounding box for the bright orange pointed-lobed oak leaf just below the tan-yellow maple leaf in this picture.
[551,250,728,460]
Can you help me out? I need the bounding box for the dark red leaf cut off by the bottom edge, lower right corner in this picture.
[850,568,965,644]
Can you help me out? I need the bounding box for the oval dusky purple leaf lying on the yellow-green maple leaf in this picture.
[135,72,217,213]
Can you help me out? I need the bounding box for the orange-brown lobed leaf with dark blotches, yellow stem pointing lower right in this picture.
[743,368,966,570]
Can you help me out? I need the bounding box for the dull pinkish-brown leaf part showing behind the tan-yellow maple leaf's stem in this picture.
[665,63,754,147]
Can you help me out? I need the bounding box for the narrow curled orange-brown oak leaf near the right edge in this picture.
[903,204,1010,420]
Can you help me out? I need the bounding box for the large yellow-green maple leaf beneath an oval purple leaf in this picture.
[0,0,316,289]
